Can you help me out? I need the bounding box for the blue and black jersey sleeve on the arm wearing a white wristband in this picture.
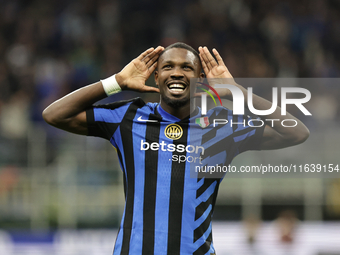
[86,99,139,140]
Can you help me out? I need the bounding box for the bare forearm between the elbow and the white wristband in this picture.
[43,81,107,127]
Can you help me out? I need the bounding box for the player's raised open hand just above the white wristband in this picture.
[116,46,164,92]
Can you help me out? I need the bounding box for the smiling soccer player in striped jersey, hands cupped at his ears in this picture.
[43,43,309,255]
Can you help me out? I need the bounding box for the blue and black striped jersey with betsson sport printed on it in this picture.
[87,98,263,255]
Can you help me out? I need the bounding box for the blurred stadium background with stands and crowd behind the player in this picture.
[0,0,340,255]
